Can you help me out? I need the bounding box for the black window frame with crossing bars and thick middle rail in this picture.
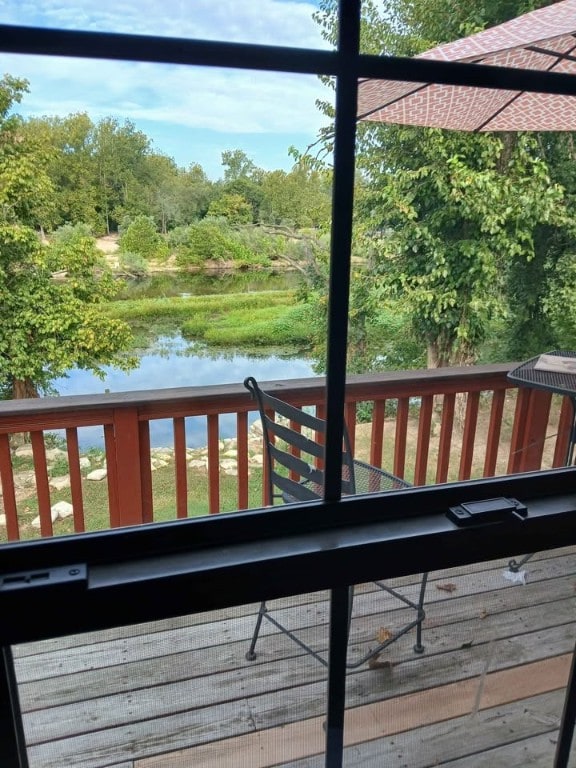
[0,0,576,767]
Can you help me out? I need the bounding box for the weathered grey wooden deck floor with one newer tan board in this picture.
[15,548,576,768]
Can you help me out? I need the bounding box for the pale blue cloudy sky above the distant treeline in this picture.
[0,0,331,180]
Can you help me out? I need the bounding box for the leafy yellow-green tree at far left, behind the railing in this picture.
[0,75,133,397]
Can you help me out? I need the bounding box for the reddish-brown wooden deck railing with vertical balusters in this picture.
[0,365,570,540]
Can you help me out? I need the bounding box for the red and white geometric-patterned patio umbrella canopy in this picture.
[358,0,576,131]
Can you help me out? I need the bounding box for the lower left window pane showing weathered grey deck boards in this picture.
[13,595,327,768]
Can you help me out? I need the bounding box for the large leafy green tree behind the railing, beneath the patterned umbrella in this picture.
[316,0,572,365]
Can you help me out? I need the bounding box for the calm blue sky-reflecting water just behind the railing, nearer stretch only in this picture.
[54,335,314,451]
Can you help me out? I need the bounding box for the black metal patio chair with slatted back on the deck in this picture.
[244,376,428,669]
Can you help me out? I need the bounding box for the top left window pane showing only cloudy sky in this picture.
[0,0,328,48]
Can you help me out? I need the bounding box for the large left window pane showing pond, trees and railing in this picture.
[0,56,332,540]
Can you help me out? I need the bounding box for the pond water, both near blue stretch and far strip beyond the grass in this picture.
[53,271,315,451]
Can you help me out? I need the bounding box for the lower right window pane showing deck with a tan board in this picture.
[338,549,574,766]
